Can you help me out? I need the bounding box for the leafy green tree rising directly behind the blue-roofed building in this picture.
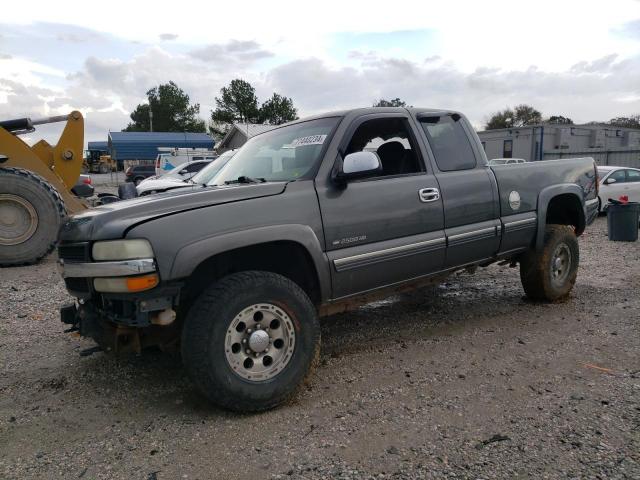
[123,81,205,132]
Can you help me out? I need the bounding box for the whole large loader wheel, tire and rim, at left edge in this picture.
[0,167,66,267]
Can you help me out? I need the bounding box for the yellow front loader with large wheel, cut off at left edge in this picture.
[0,111,88,266]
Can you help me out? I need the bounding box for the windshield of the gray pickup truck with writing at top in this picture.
[208,117,339,185]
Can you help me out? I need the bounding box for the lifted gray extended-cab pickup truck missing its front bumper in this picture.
[58,108,598,411]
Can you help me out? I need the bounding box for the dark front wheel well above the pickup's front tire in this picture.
[185,241,320,305]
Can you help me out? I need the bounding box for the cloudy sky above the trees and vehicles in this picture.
[0,0,640,144]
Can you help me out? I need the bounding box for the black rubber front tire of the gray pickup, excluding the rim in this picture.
[182,271,320,412]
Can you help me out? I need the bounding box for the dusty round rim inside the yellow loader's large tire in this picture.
[0,193,38,245]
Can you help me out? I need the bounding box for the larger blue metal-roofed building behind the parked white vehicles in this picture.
[108,132,214,166]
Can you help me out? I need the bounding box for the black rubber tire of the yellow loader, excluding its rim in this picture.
[0,167,66,267]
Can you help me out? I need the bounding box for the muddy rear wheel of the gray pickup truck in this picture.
[520,225,580,302]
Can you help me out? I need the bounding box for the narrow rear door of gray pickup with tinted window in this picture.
[417,113,501,267]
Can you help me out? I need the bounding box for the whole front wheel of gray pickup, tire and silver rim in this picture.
[182,271,320,412]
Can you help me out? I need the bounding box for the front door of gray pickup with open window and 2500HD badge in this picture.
[317,114,446,299]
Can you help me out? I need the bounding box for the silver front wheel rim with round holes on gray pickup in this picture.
[224,303,296,382]
